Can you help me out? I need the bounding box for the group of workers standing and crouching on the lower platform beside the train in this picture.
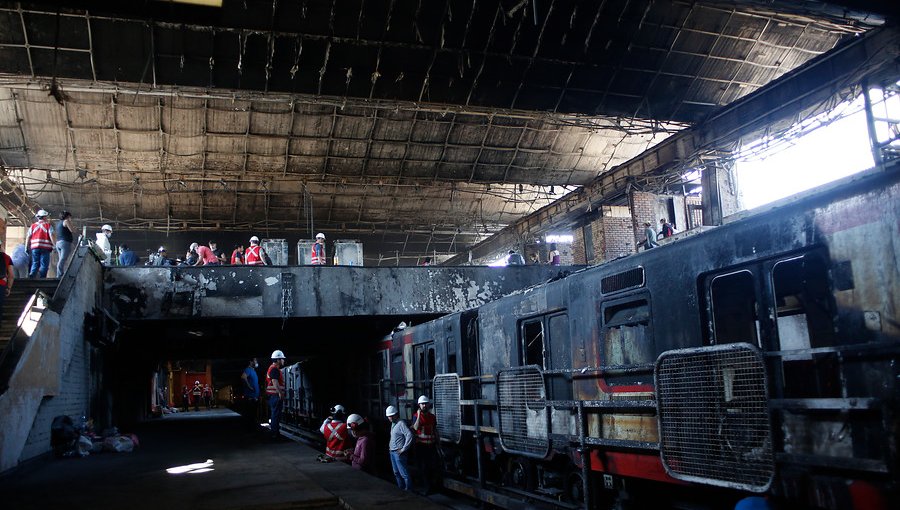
[253,350,440,494]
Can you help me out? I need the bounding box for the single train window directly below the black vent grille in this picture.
[603,299,656,365]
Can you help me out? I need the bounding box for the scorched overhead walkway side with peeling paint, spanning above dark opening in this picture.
[104,266,574,319]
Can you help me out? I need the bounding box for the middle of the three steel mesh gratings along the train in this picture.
[497,365,550,458]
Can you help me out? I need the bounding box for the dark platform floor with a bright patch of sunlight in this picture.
[0,409,471,510]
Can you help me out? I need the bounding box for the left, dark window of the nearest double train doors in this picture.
[709,271,759,346]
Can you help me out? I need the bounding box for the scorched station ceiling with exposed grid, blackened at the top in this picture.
[0,0,896,257]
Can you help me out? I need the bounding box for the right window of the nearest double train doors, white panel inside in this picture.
[772,254,835,350]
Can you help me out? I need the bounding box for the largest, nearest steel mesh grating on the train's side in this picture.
[655,344,774,492]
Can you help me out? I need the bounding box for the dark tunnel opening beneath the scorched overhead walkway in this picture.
[109,314,438,427]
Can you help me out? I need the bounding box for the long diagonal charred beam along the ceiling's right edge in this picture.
[445,23,900,265]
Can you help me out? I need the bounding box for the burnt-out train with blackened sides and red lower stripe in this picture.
[285,163,900,509]
